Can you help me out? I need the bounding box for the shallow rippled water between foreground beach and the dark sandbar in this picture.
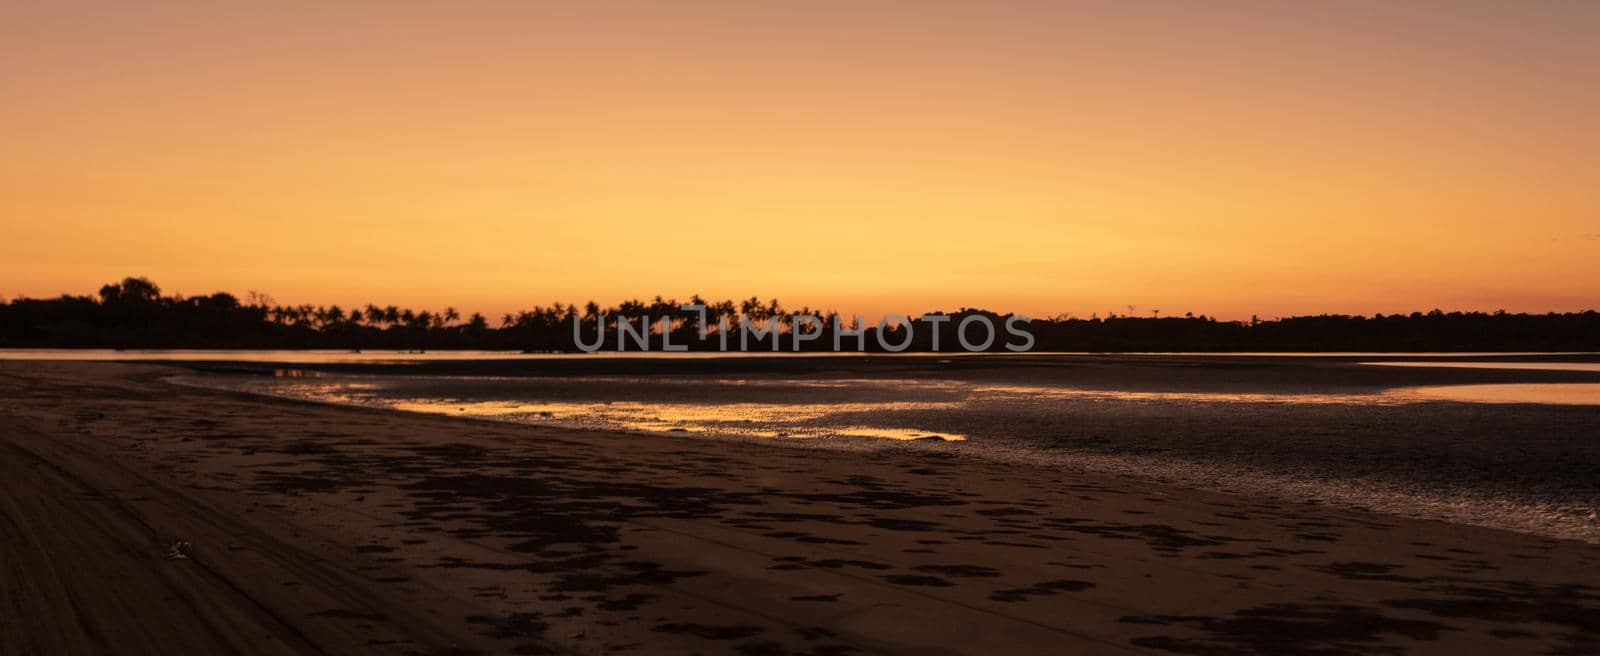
[179,368,1600,541]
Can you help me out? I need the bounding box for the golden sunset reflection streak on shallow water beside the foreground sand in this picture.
[212,368,1600,442]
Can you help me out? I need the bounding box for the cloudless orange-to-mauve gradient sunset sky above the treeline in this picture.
[0,0,1600,318]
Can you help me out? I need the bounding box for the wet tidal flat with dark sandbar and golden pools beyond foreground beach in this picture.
[190,354,1600,544]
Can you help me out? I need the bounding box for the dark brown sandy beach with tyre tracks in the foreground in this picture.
[0,362,1600,654]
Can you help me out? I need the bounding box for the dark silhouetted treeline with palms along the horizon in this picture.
[0,278,1600,352]
